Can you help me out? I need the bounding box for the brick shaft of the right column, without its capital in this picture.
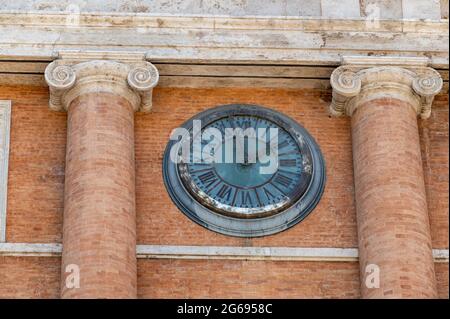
[352,98,437,298]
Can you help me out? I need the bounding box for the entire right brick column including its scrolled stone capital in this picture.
[330,58,442,298]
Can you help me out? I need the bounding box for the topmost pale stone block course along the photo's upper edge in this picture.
[0,0,448,19]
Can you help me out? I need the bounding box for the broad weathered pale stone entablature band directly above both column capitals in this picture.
[0,12,449,68]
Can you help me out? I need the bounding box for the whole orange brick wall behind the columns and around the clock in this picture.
[0,86,448,297]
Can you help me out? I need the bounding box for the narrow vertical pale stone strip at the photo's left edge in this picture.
[0,101,11,242]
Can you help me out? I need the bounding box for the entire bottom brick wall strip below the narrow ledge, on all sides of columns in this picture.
[0,257,449,298]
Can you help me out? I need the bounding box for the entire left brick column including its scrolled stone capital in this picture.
[45,55,158,298]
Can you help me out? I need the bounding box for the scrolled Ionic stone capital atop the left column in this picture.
[45,55,159,112]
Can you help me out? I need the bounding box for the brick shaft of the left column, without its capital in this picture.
[61,92,136,298]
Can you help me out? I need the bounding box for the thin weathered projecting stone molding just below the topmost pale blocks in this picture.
[0,11,449,35]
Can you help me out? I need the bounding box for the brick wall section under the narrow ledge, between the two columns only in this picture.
[138,259,359,298]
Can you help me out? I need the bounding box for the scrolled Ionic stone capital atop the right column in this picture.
[329,57,443,119]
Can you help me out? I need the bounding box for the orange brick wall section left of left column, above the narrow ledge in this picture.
[0,86,67,243]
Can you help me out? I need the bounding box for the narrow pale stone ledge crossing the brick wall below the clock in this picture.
[0,243,449,263]
